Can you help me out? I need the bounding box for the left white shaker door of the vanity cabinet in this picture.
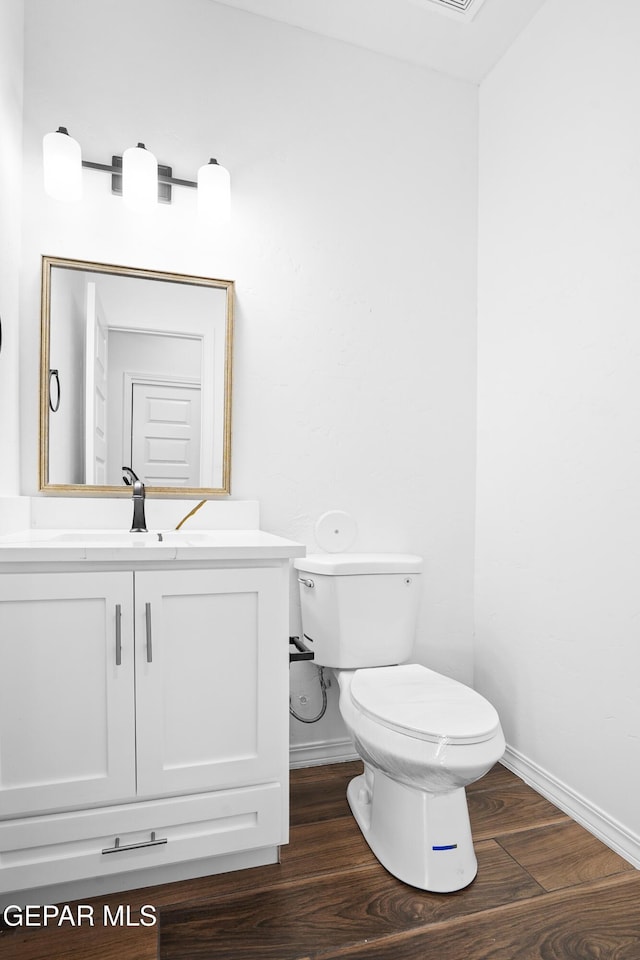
[0,573,135,816]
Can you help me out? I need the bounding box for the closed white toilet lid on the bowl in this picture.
[351,663,500,743]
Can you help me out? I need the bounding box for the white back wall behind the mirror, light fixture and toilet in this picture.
[21,0,477,752]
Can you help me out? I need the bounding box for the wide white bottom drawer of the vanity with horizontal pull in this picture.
[0,783,280,892]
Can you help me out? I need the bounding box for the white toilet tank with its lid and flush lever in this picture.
[294,553,422,669]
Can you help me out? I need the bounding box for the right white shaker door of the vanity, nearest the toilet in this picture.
[135,568,288,796]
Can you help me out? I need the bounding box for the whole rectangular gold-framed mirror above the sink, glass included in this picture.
[40,257,233,496]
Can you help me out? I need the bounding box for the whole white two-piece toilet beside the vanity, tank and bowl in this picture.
[294,553,505,893]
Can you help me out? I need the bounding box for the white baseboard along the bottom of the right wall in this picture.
[502,746,640,870]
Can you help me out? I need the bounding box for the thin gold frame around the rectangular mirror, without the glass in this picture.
[39,256,234,498]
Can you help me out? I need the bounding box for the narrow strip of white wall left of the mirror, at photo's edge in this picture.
[0,0,24,494]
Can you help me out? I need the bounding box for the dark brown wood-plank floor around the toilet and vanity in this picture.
[0,763,640,960]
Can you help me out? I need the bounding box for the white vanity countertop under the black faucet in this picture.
[0,528,306,564]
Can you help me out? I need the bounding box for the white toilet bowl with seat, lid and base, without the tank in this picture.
[335,664,505,893]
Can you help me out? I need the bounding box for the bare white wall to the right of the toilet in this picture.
[476,0,640,864]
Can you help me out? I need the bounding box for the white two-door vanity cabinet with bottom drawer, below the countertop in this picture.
[0,548,296,904]
